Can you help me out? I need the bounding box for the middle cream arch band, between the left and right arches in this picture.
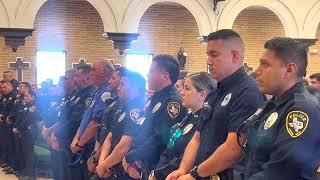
[122,0,213,35]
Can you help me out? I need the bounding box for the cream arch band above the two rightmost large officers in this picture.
[218,0,299,37]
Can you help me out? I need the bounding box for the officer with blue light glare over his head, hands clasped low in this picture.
[96,70,148,179]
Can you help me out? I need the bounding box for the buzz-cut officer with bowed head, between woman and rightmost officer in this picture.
[167,29,263,180]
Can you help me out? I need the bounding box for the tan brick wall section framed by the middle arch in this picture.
[133,4,206,72]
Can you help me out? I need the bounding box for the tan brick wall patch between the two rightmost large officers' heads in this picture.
[233,7,285,69]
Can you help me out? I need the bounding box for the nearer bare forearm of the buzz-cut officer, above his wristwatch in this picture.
[198,133,245,177]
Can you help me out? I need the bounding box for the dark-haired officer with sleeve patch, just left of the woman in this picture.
[123,55,187,178]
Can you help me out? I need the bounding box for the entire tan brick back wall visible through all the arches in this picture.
[0,0,320,82]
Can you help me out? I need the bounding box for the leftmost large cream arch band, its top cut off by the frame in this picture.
[16,0,118,32]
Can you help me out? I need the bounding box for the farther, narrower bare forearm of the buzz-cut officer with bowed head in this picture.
[179,131,200,173]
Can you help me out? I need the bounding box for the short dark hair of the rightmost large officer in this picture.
[264,37,308,78]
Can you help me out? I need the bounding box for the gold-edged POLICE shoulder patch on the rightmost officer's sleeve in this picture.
[286,111,309,138]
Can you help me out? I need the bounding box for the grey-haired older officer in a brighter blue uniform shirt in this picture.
[70,60,114,180]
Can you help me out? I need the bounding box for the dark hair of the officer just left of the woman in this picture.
[152,54,180,84]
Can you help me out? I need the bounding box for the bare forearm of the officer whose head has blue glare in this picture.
[103,135,132,168]
